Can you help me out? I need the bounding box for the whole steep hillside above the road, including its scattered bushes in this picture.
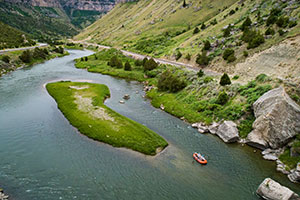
[75,0,300,78]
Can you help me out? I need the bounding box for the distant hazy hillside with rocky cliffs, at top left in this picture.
[0,0,136,39]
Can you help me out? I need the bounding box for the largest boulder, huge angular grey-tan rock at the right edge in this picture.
[247,87,300,149]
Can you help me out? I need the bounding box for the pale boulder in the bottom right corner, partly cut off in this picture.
[256,178,300,200]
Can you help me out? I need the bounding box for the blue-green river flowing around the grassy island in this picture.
[0,50,300,200]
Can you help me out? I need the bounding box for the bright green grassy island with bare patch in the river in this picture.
[46,82,168,155]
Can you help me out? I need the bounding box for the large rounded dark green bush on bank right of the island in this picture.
[157,70,186,92]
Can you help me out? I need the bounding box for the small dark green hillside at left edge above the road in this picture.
[0,22,35,49]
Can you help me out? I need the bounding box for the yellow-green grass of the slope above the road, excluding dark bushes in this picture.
[75,0,300,68]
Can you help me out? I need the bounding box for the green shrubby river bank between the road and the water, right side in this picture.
[76,50,300,181]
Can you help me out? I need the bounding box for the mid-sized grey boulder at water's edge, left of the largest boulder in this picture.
[216,121,239,143]
